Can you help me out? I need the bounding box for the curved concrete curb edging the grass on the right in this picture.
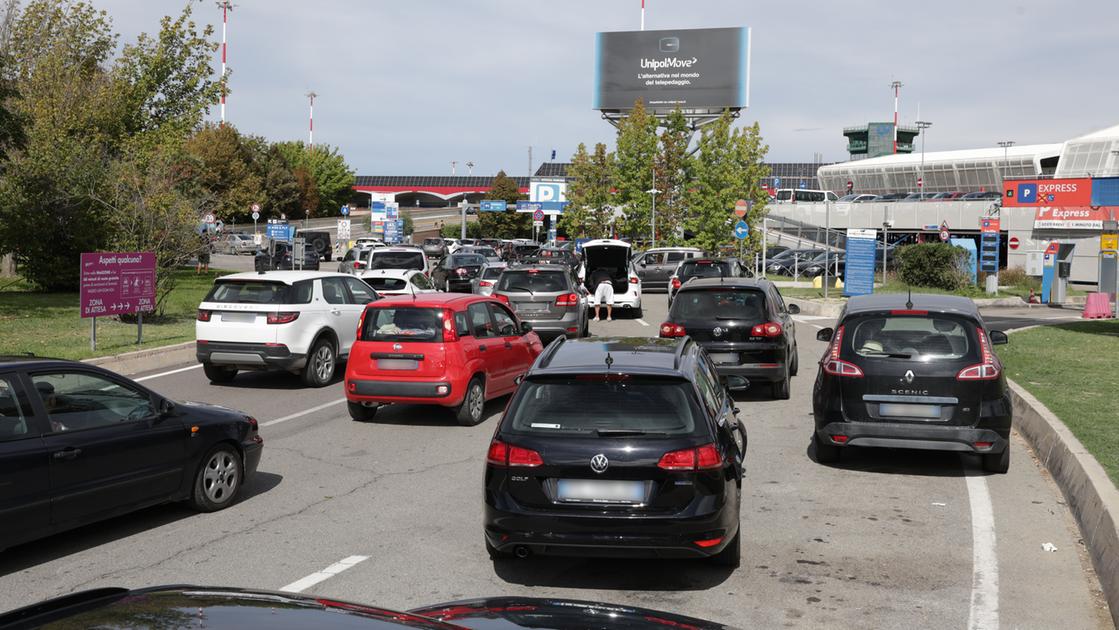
[1006,379,1119,627]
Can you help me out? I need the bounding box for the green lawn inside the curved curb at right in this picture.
[997,320,1119,486]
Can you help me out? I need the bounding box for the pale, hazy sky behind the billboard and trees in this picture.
[91,0,1119,175]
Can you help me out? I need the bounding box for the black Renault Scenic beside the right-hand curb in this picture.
[812,294,1012,472]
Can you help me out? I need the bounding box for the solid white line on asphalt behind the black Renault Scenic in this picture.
[965,476,1010,630]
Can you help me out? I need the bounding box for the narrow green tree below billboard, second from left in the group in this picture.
[614,101,657,238]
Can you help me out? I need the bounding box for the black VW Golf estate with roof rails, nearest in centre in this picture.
[485,337,749,566]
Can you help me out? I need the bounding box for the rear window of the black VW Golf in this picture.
[507,374,705,438]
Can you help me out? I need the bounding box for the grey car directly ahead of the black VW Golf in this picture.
[493,265,590,339]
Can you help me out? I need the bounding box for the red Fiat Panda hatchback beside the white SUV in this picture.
[346,293,544,426]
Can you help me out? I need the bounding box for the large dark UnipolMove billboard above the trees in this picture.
[593,27,750,110]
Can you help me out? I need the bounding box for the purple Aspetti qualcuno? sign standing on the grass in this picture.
[81,252,156,317]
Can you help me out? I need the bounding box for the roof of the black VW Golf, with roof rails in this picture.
[529,337,690,376]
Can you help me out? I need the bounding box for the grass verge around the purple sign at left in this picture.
[0,269,232,359]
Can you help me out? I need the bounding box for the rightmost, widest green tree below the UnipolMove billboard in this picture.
[685,112,769,252]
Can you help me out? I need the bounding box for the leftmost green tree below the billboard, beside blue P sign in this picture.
[560,142,614,238]
